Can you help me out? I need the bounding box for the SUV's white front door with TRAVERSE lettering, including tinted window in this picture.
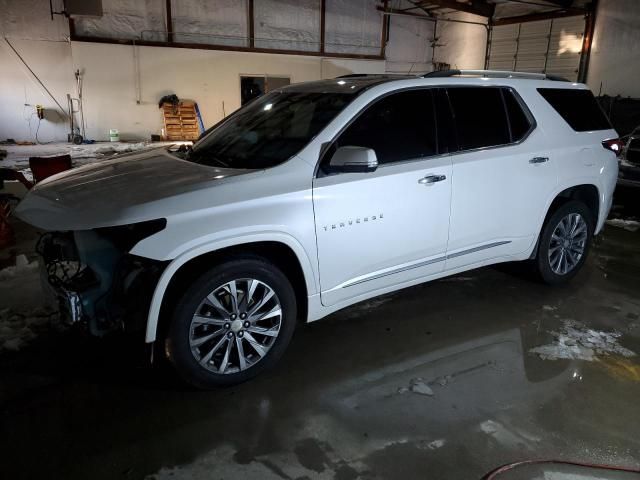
[313,89,451,306]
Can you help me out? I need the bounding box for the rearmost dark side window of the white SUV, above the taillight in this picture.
[538,88,612,132]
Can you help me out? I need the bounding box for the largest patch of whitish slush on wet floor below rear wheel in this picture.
[529,320,636,362]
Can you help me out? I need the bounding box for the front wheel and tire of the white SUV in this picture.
[165,256,297,389]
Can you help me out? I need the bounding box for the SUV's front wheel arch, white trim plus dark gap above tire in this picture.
[145,234,317,343]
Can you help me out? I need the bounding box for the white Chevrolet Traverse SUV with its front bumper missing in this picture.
[17,71,620,388]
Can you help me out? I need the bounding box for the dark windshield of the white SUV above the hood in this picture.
[188,90,355,169]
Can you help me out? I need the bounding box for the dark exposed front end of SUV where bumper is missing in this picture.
[37,220,167,336]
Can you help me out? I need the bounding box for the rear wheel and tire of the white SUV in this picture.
[534,200,594,285]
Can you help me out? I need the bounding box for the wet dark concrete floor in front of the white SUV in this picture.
[0,218,640,480]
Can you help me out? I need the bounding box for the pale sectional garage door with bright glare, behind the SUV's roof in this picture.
[488,16,585,81]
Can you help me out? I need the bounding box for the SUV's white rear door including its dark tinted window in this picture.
[446,86,557,269]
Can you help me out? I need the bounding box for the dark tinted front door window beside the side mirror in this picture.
[337,90,437,164]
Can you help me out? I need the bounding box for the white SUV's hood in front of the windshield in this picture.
[15,148,250,230]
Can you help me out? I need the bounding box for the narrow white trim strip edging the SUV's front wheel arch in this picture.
[145,231,318,343]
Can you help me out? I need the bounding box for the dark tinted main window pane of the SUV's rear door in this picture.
[447,87,510,150]
